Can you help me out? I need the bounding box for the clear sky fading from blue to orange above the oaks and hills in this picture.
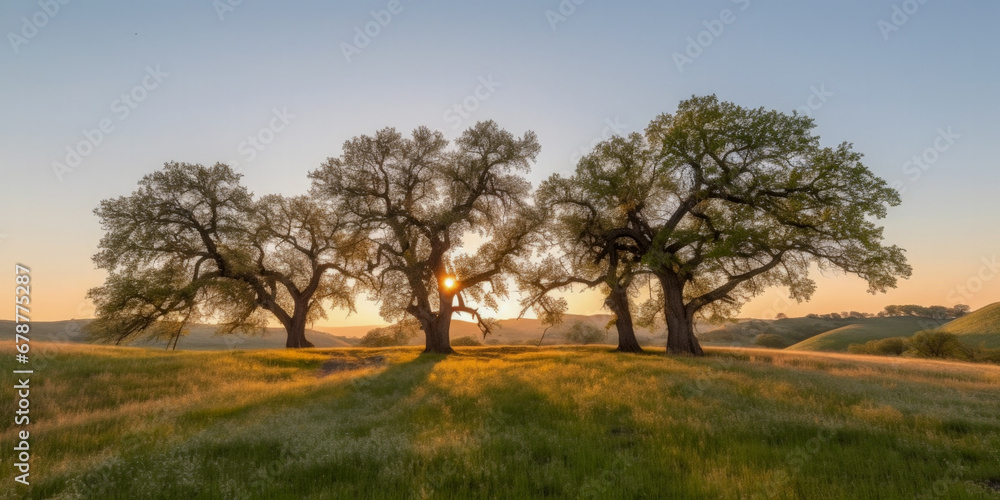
[0,0,1000,325]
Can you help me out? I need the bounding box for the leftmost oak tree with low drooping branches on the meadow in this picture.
[88,163,366,347]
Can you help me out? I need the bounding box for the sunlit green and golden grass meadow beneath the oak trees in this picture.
[0,344,1000,499]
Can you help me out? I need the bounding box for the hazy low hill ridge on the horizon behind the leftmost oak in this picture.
[0,320,352,351]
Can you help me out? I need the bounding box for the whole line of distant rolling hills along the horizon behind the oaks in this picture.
[11,303,1000,352]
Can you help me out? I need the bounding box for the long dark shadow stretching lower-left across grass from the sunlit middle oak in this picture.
[24,354,444,498]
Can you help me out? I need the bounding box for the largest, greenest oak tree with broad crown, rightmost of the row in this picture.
[560,96,911,354]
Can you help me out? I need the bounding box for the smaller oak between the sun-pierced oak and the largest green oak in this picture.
[518,142,656,352]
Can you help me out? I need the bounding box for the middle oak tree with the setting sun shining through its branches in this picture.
[310,121,541,353]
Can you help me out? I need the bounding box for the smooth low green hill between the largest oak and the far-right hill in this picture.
[787,316,945,352]
